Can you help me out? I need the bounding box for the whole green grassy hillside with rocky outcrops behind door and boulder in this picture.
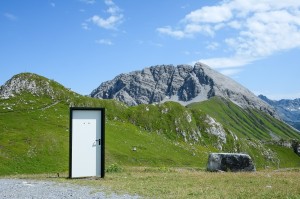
[0,73,300,175]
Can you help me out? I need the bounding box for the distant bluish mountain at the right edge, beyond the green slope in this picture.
[258,95,300,131]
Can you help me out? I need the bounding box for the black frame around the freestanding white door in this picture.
[69,107,105,178]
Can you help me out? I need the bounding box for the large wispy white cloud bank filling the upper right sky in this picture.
[156,0,300,68]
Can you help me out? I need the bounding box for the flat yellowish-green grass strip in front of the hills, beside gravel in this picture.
[8,167,300,198]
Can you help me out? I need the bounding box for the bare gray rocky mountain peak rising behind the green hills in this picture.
[91,63,274,115]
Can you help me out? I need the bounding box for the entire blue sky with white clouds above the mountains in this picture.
[0,0,300,99]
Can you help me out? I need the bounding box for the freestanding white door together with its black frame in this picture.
[69,107,105,178]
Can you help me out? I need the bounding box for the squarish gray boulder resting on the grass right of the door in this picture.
[207,153,256,172]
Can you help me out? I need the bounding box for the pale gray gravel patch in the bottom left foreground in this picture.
[0,179,139,199]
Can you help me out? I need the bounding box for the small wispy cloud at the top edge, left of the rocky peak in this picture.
[88,0,124,29]
